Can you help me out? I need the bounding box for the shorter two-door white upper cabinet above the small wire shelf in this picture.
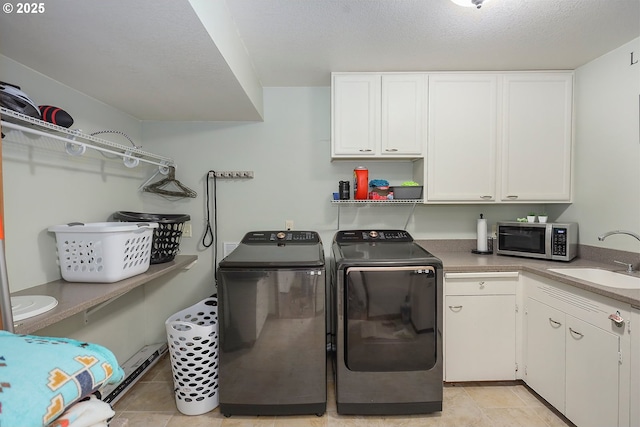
[331,73,426,158]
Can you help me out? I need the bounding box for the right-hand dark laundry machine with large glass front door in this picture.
[330,230,443,415]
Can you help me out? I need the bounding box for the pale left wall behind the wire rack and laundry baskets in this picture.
[0,56,194,362]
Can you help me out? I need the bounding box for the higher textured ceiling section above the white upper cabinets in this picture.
[228,0,640,86]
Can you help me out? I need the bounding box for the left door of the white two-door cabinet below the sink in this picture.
[525,298,564,412]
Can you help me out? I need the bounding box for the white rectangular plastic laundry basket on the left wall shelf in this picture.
[49,222,158,283]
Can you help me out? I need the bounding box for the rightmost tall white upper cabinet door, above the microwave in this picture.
[501,73,573,202]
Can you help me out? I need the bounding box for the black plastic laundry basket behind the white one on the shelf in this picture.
[113,211,191,264]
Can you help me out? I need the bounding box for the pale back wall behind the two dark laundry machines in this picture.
[143,88,535,306]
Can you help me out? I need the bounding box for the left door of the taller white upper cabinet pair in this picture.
[425,74,498,202]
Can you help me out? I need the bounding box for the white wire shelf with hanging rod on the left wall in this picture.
[0,108,175,170]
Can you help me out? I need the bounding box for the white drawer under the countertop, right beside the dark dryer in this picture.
[444,271,519,295]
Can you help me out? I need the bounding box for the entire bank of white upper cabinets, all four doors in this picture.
[331,71,573,203]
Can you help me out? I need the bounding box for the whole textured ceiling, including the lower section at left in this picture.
[0,0,640,120]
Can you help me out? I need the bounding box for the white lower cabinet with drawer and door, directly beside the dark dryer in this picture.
[444,272,518,382]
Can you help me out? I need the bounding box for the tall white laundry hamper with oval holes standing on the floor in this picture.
[165,298,219,415]
